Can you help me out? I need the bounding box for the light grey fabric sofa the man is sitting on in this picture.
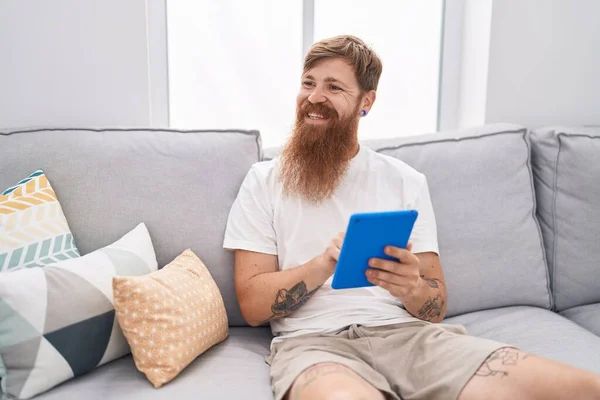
[0,124,600,400]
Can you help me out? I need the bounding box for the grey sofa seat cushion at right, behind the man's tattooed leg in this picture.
[444,307,600,373]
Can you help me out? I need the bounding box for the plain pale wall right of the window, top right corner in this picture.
[485,0,600,127]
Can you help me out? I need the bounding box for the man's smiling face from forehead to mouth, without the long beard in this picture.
[296,58,361,129]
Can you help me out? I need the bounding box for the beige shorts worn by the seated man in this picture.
[266,322,513,400]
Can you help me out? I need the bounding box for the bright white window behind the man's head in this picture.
[167,0,443,147]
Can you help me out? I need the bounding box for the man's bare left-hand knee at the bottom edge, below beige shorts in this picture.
[286,363,384,400]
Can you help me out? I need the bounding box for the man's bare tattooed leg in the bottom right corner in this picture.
[459,348,600,400]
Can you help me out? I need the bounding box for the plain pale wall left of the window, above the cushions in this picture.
[0,0,168,128]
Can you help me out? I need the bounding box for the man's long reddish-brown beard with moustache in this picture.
[279,101,359,204]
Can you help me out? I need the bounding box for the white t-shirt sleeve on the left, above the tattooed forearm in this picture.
[223,166,277,255]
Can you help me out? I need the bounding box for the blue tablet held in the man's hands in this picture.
[331,210,418,289]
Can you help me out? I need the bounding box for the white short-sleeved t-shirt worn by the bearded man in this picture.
[223,146,439,341]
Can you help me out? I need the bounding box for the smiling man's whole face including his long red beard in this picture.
[280,59,373,203]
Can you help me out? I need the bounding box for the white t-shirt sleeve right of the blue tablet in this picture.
[409,177,440,255]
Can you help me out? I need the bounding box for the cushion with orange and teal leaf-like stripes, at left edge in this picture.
[0,170,79,273]
